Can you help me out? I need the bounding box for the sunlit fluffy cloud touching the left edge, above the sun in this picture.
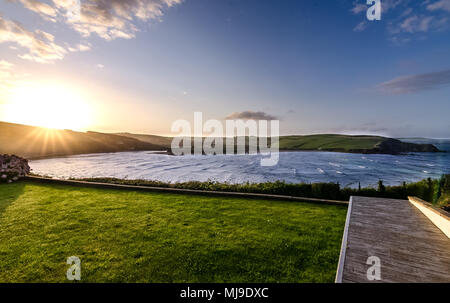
[0,16,67,63]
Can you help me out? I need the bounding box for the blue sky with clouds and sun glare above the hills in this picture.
[0,0,450,138]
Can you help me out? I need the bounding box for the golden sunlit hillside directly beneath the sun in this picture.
[0,122,165,159]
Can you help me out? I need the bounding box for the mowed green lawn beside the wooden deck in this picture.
[0,182,347,282]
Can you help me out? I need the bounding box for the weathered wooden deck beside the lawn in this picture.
[336,197,450,283]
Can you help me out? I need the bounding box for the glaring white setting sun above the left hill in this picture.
[3,83,91,130]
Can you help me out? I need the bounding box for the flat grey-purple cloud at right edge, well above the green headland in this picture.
[377,69,450,94]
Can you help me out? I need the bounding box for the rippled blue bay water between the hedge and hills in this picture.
[30,148,450,187]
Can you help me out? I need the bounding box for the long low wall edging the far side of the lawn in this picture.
[24,176,348,205]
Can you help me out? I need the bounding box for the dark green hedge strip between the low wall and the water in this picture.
[32,174,450,211]
